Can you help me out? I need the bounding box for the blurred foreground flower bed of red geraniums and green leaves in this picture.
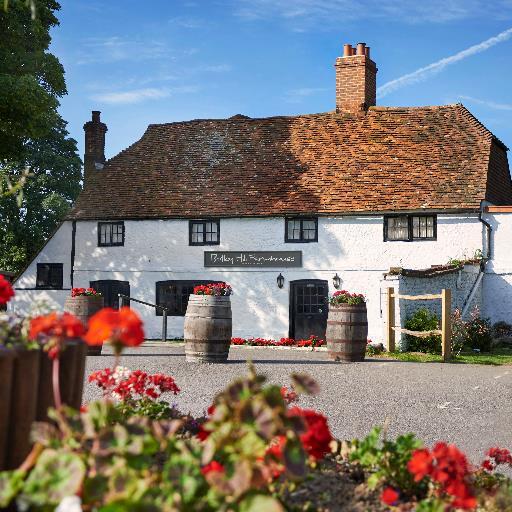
[0,286,512,512]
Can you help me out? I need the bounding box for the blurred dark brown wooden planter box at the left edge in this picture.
[0,340,87,471]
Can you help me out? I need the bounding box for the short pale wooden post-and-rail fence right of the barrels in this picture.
[386,288,452,361]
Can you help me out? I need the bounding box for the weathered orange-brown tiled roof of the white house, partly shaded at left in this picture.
[69,105,512,219]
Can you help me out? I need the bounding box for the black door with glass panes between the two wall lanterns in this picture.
[290,279,329,340]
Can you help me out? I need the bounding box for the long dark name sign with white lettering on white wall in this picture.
[204,251,302,268]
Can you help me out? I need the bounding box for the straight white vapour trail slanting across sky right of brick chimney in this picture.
[377,28,512,98]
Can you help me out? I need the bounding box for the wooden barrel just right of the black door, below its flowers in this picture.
[326,304,368,362]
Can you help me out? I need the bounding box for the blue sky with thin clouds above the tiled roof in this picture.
[51,0,512,157]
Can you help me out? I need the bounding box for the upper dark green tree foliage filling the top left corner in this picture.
[0,0,66,162]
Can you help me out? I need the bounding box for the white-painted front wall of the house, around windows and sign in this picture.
[14,215,482,340]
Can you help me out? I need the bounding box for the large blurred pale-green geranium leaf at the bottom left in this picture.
[23,450,85,506]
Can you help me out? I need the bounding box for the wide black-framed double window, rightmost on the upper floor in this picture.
[384,215,437,242]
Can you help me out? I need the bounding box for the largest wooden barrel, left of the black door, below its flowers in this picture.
[185,295,232,363]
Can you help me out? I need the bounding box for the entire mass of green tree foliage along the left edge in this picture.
[0,0,81,271]
